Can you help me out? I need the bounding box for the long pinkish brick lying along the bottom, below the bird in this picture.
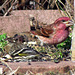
[2,61,75,75]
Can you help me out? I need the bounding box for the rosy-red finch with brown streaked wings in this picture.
[31,17,73,45]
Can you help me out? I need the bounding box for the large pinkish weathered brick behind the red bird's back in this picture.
[0,10,61,36]
